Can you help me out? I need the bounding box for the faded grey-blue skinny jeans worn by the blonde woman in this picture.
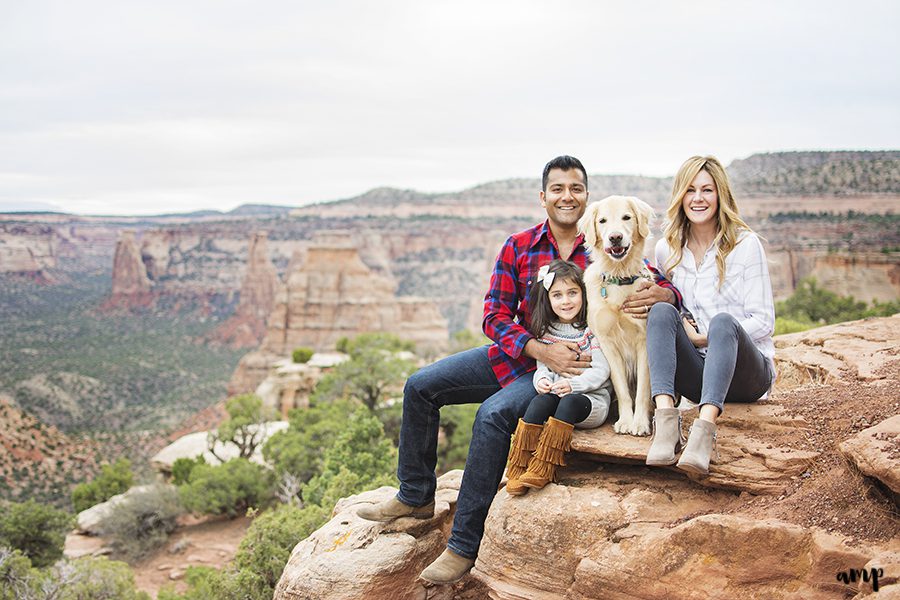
[647,302,772,412]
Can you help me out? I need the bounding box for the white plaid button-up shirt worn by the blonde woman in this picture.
[656,232,775,372]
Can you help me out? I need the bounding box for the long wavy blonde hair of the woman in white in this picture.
[663,156,752,289]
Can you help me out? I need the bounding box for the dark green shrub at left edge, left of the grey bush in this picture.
[0,500,75,567]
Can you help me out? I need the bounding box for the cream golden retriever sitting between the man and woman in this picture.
[578,196,654,435]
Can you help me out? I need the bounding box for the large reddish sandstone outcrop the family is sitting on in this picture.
[275,315,900,600]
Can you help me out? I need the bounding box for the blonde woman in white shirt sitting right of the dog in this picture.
[647,156,775,474]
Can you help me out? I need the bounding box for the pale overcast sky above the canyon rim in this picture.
[0,0,900,214]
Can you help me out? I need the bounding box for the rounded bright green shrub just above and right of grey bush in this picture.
[178,458,275,517]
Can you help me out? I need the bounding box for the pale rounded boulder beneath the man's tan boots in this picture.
[274,471,485,600]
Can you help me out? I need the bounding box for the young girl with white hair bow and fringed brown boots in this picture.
[506,260,610,496]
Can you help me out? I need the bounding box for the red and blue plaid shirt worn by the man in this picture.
[482,221,681,386]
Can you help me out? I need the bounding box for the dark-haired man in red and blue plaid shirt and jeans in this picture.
[358,156,678,584]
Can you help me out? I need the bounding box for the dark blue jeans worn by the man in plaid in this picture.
[397,346,535,559]
